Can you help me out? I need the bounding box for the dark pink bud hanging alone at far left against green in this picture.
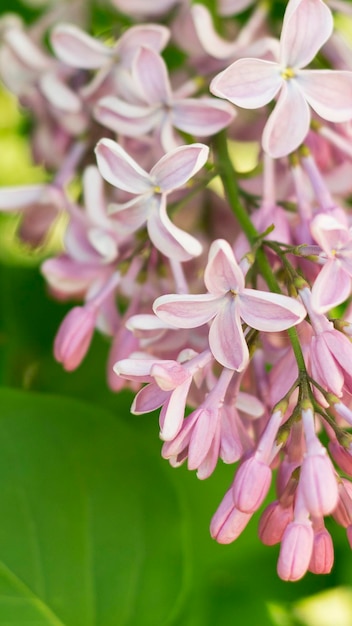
[54,306,96,371]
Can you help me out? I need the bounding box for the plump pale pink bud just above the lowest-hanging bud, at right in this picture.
[300,447,338,517]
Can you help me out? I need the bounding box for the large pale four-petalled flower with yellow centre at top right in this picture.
[210,0,352,158]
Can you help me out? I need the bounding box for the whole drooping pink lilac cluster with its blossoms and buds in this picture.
[0,0,352,581]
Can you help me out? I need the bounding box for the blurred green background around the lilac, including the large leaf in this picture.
[0,0,352,626]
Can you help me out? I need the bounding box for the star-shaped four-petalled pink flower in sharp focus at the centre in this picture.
[154,239,306,371]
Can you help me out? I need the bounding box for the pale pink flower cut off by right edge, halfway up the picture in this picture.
[310,214,352,313]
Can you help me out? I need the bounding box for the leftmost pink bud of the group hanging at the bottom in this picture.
[210,489,252,544]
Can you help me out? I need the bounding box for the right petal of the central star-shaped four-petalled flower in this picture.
[238,289,306,332]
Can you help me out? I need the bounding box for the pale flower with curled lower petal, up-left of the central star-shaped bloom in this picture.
[95,139,209,261]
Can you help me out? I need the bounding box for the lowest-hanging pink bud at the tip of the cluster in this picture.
[277,520,314,581]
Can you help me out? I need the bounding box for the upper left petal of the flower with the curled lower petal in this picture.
[95,139,152,194]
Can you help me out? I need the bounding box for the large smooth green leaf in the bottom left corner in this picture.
[0,389,188,626]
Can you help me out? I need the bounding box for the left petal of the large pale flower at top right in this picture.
[210,59,283,109]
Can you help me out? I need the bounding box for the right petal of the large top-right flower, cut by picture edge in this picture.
[296,70,352,122]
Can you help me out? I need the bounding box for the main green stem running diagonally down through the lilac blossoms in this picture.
[214,131,308,370]
